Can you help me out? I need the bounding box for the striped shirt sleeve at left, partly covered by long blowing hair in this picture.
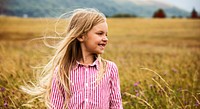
[50,70,65,109]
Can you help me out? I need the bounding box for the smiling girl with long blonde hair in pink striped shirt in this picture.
[24,9,122,109]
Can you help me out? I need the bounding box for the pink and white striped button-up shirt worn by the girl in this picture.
[50,60,123,109]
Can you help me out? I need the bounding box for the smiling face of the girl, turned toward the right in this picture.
[80,22,108,54]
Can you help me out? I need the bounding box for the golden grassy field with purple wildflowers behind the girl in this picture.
[0,16,200,109]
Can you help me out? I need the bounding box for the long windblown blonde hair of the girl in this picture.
[22,8,106,108]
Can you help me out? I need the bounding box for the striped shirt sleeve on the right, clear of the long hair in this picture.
[110,63,123,109]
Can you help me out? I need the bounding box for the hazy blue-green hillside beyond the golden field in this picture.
[0,0,189,17]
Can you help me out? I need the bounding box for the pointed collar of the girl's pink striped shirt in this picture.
[73,58,100,70]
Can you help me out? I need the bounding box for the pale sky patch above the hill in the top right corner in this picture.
[156,0,200,12]
